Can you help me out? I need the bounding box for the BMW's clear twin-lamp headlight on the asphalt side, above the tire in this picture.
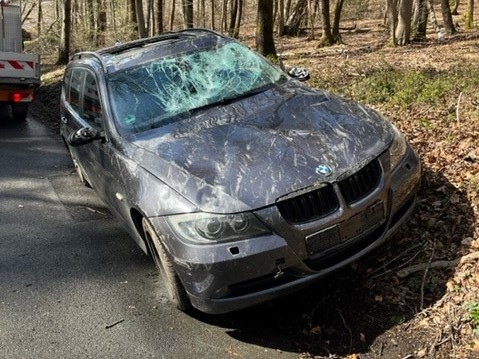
[167,213,271,243]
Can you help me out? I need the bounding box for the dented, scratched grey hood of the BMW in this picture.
[128,82,392,213]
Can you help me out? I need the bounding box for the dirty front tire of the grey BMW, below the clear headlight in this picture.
[142,218,191,311]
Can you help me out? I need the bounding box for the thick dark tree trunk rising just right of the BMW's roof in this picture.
[256,0,278,60]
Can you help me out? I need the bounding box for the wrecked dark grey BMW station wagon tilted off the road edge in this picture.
[61,29,420,313]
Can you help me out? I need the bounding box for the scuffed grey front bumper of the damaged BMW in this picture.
[151,146,421,313]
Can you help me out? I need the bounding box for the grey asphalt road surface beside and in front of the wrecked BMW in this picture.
[0,113,299,359]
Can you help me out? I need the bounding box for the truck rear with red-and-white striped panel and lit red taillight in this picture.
[0,0,40,120]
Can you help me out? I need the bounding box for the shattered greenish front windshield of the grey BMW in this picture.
[108,42,284,132]
